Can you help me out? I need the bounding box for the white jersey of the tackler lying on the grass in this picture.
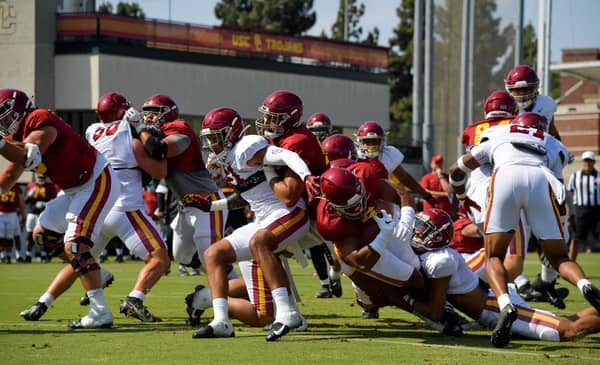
[419,247,479,294]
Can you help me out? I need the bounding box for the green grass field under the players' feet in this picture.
[0,254,600,365]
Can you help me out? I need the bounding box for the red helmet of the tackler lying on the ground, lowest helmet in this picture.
[411,208,454,251]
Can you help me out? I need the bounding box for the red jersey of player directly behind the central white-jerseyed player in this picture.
[272,125,327,175]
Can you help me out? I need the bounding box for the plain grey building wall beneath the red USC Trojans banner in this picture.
[54,54,389,128]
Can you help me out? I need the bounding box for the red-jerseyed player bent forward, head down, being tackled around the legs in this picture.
[317,163,423,296]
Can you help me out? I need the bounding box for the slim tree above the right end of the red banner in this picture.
[331,0,379,46]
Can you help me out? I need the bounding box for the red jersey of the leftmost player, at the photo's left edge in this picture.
[15,109,98,189]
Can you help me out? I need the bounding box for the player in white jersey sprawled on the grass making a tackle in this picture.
[404,209,600,341]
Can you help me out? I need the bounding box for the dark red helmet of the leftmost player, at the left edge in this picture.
[0,89,34,136]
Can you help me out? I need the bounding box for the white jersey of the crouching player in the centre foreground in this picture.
[221,135,306,221]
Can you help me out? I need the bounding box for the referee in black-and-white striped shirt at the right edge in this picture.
[567,151,600,261]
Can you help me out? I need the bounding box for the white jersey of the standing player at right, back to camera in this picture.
[470,124,568,178]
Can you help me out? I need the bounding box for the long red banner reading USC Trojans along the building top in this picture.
[57,14,388,68]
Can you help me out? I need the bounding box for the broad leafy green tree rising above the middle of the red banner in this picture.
[215,0,317,36]
